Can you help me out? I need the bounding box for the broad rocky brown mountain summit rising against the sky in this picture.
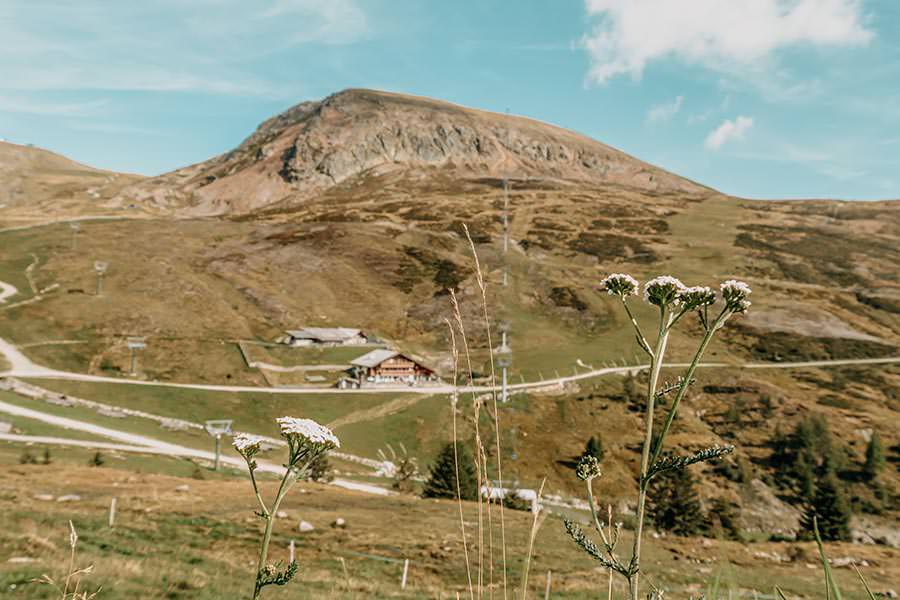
[118,89,709,215]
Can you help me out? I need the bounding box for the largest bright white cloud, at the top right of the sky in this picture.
[582,0,874,84]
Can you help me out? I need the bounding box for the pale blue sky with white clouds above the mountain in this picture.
[0,0,900,200]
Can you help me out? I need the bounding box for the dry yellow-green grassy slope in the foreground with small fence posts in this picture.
[0,462,900,600]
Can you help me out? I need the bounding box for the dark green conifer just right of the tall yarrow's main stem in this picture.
[647,462,706,536]
